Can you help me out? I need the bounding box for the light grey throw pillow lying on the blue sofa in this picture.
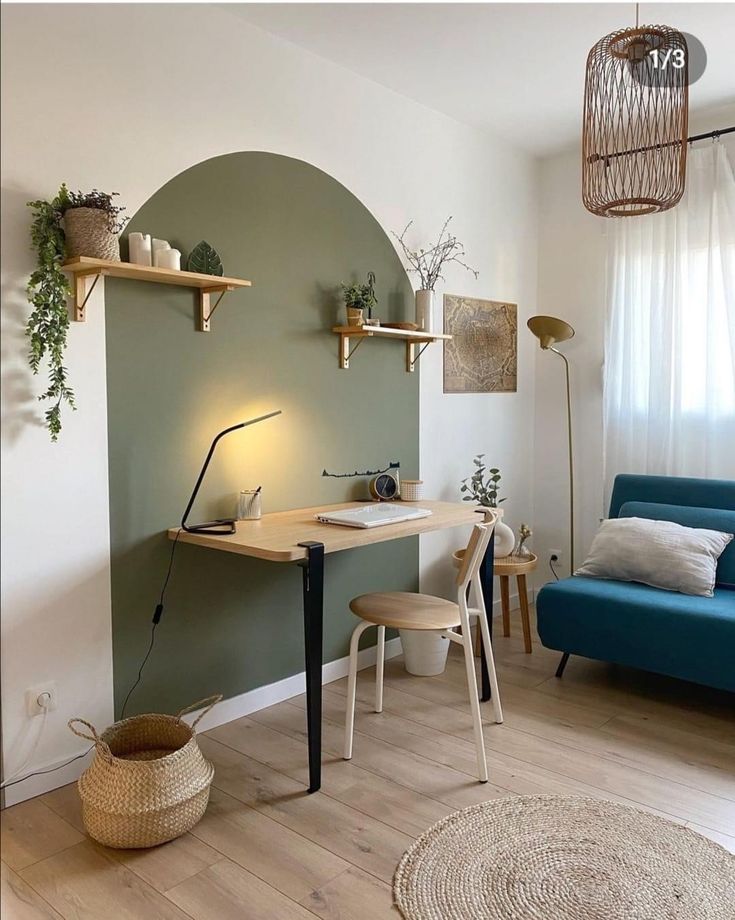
[574,517,733,597]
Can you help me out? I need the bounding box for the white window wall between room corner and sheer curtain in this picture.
[534,105,735,583]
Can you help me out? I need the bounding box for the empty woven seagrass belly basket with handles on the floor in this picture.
[69,695,222,849]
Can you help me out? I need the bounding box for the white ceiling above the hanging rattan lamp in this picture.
[227,3,735,156]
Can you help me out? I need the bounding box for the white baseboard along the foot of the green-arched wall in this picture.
[4,590,534,807]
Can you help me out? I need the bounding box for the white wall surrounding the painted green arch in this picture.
[2,5,536,802]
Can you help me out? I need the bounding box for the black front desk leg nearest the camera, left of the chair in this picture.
[299,542,324,792]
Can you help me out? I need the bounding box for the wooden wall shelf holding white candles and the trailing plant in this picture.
[62,256,252,332]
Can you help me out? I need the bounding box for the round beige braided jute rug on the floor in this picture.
[393,795,735,920]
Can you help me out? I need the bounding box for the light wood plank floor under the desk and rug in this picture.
[2,618,735,920]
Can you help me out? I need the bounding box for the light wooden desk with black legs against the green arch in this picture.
[168,501,494,792]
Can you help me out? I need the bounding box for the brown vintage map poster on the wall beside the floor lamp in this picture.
[444,294,518,393]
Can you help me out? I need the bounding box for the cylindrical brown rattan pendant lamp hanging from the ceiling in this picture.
[582,4,689,217]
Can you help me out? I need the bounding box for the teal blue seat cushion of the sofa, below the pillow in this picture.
[536,576,735,691]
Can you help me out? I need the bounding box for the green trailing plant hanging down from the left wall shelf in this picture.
[26,185,75,441]
